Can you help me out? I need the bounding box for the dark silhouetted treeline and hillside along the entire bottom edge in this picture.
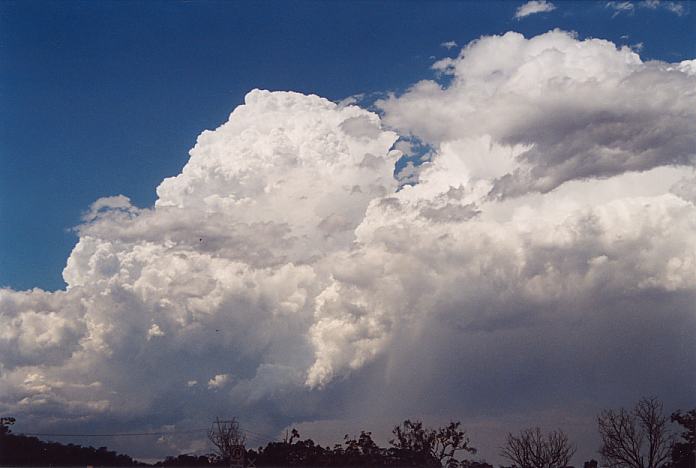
[0,398,696,468]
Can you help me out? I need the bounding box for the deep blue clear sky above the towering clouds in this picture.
[0,1,696,290]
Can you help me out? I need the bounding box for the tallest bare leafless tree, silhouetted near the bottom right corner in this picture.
[597,398,672,468]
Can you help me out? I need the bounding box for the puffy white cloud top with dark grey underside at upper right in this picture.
[378,31,696,197]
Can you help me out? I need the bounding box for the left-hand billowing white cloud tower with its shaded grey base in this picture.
[0,91,400,438]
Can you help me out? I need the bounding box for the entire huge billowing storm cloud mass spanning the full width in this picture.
[0,31,696,458]
